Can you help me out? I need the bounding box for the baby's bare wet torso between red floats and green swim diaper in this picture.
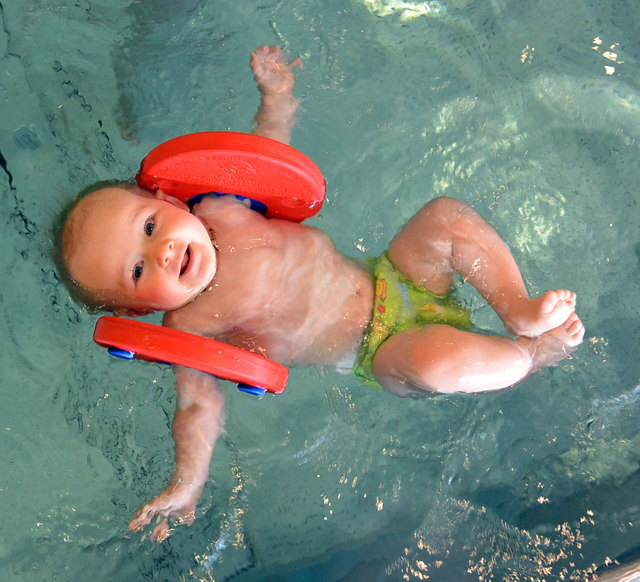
[165,198,373,365]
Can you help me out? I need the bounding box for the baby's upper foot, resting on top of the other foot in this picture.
[504,289,576,337]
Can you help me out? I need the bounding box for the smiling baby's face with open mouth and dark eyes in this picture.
[67,188,216,311]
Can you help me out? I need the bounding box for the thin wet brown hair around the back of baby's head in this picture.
[53,180,140,311]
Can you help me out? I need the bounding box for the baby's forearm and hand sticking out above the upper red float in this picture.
[250,46,302,144]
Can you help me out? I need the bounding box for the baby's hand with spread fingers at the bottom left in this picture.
[129,485,199,542]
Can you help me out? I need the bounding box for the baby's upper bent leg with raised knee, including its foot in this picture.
[389,198,576,337]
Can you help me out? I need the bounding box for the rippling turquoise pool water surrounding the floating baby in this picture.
[0,0,640,582]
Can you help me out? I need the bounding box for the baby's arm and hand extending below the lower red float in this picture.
[129,366,224,541]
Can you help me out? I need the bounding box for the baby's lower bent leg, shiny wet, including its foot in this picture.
[373,313,584,396]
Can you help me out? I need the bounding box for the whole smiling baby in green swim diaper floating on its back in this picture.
[61,47,584,540]
